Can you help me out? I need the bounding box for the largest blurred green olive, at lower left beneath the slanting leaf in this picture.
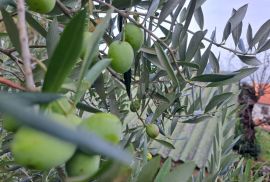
[11,127,76,170]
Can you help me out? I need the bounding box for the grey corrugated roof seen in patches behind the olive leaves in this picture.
[125,85,238,168]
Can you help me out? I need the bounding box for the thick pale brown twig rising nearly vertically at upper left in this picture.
[17,0,35,91]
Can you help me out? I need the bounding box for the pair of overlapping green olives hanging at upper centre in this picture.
[108,23,144,73]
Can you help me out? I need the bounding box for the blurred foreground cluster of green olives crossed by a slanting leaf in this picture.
[4,99,122,181]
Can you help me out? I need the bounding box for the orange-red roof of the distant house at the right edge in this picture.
[255,83,270,105]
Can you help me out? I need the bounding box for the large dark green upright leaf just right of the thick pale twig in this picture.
[43,11,86,92]
